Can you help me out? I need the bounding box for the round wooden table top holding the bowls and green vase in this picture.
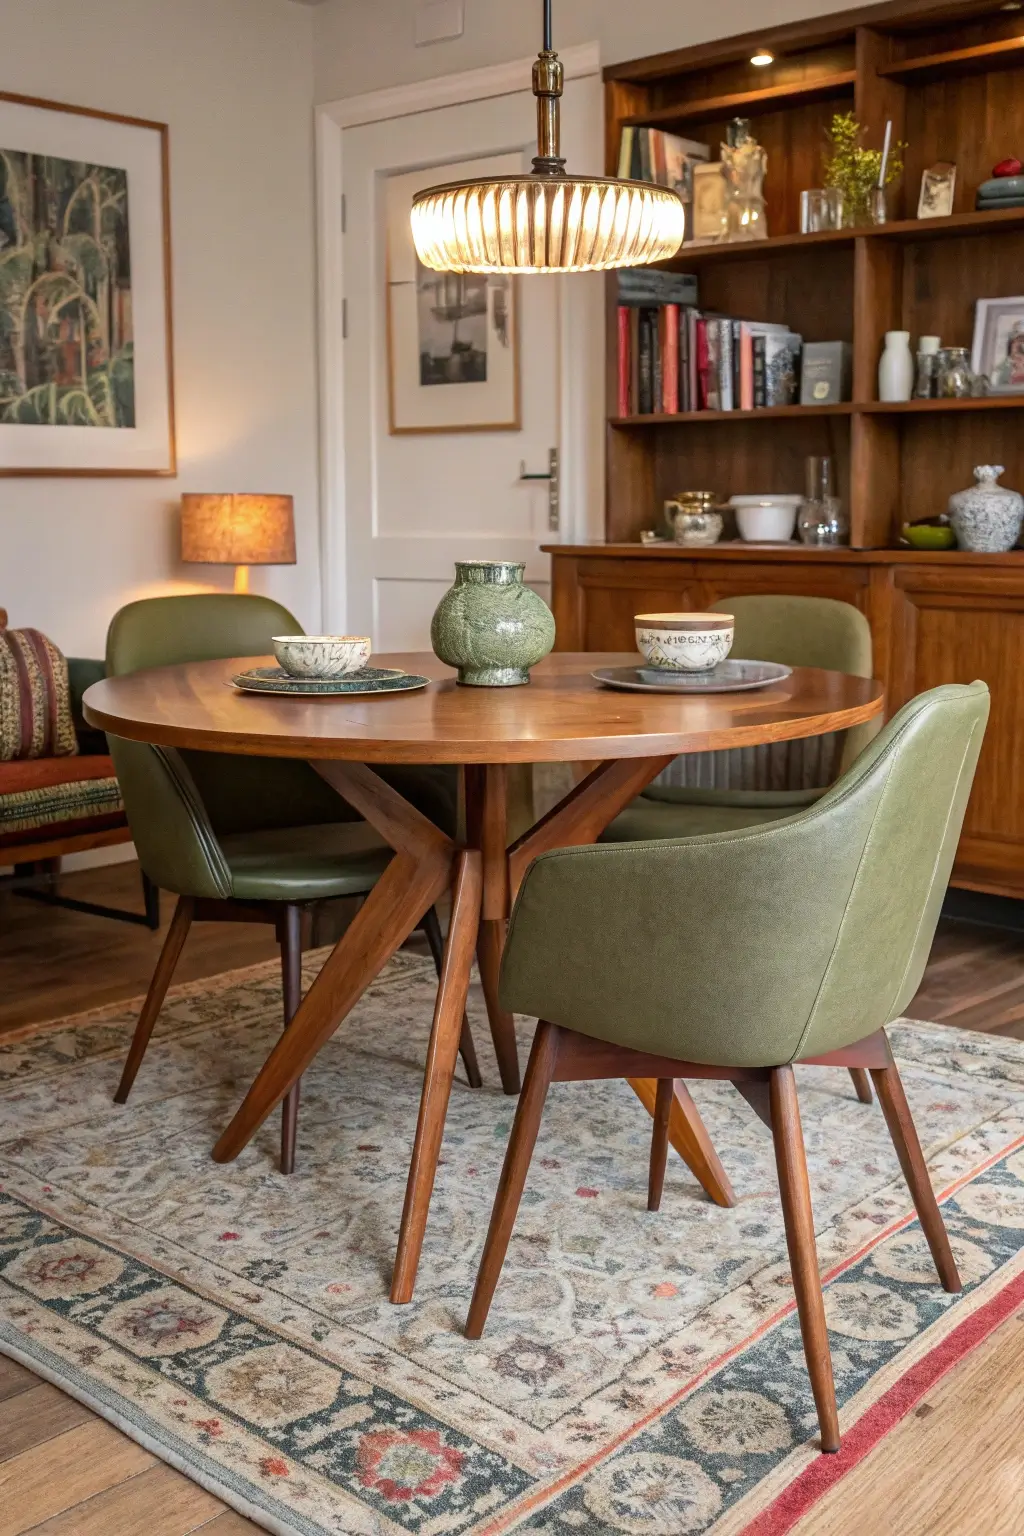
[84,651,883,763]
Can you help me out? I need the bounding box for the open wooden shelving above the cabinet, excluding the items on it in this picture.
[605,0,1024,548]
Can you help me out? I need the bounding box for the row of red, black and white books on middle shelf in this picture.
[617,301,803,416]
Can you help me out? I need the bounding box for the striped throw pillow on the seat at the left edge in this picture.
[0,608,78,763]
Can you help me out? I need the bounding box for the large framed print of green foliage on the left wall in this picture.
[0,92,175,475]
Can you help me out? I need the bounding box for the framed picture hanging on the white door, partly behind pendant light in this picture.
[385,154,522,435]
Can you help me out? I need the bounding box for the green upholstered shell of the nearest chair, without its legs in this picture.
[500,682,989,1066]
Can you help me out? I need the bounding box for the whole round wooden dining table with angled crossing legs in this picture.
[84,653,883,1303]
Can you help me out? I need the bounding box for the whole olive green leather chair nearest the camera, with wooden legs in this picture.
[467,682,989,1450]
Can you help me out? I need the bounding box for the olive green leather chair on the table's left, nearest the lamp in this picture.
[106,593,481,1174]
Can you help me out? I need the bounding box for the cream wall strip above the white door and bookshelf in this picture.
[313,0,846,101]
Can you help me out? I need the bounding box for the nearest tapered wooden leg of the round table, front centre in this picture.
[391,849,482,1303]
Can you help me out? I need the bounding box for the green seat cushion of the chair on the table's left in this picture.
[220,822,393,902]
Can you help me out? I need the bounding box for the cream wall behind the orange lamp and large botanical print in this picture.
[0,0,319,654]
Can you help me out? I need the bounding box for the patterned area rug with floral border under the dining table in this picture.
[0,955,1024,1536]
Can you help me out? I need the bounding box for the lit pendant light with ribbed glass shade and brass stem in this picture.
[411,0,685,272]
